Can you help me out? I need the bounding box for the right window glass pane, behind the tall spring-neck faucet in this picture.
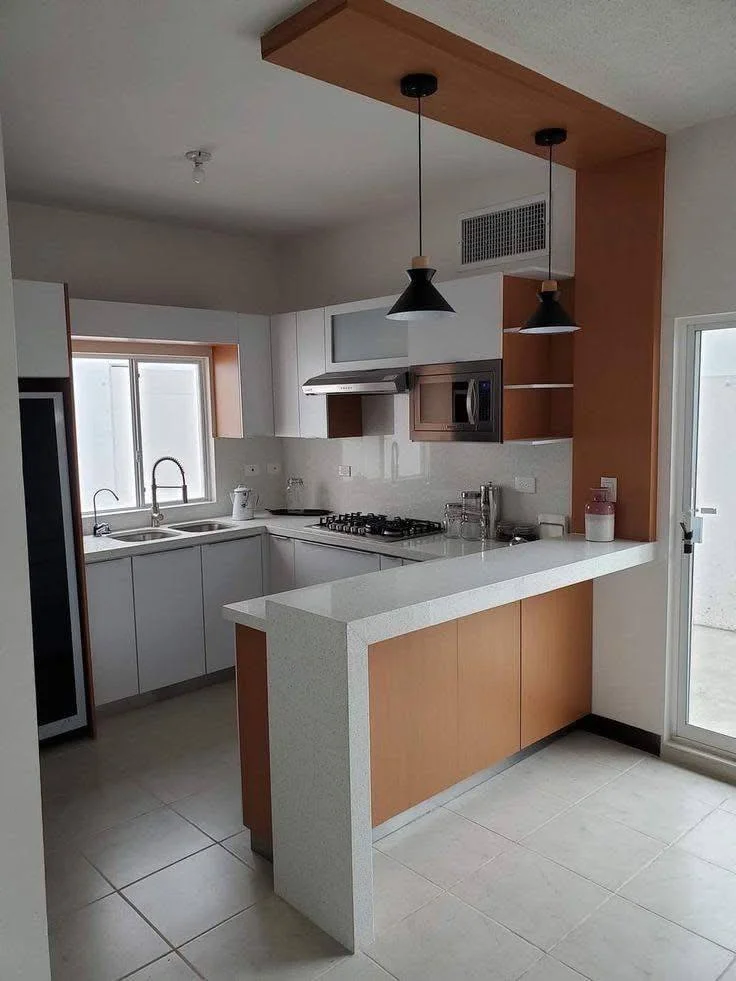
[138,361,206,504]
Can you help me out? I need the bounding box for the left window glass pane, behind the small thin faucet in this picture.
[73,358,137,511]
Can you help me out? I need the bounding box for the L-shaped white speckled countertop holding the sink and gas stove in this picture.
[84,514,492,562]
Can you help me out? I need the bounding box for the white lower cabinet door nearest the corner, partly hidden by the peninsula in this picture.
[202,535,263,674]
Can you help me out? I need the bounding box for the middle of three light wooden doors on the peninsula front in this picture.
[457,603,521,780]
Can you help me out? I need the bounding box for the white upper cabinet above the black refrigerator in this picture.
[13,279,69,378]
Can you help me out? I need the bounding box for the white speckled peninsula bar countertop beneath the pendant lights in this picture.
[224,535,656,644]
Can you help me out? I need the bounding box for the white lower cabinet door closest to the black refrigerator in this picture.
[86,559,139,705]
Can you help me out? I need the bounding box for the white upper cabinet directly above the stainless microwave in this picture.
[409,273,503,365]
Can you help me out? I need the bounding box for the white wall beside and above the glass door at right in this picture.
[593,109,736,733]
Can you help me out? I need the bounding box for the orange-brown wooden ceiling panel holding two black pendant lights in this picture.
[261,0,665,167]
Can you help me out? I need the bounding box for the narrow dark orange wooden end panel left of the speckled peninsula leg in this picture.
[235,624,273,856]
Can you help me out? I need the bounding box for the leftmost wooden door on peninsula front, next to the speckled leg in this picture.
[368,621,458,827]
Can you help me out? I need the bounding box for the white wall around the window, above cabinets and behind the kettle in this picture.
[10,202,283,533]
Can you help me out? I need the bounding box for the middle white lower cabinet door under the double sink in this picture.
[133,548,205,692]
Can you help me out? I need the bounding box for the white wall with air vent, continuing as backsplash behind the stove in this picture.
[280,165,575,520]
